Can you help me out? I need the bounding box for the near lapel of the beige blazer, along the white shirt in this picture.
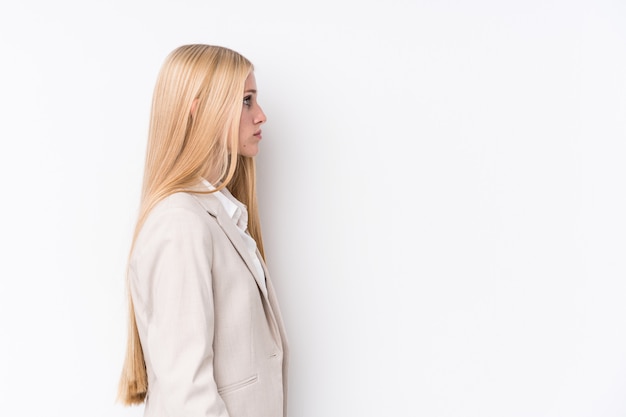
[191,193,268,299]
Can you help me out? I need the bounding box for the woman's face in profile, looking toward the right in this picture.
[238,72,267,156]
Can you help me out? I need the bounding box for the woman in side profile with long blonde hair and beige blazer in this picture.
[119,45,287,417]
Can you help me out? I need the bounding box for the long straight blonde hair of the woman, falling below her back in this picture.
[118,44,265,405]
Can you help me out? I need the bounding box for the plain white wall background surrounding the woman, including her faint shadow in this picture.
[0,0,626,417]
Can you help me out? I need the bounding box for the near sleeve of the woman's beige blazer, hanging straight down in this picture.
[131,207,228,417]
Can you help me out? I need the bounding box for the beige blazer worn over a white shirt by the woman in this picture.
[129,189,288,417]
